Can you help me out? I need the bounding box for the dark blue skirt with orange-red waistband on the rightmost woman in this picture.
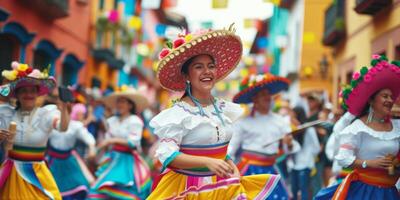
[314,169,400,200]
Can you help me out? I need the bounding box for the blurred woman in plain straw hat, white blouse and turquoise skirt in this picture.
[88,86,151,199]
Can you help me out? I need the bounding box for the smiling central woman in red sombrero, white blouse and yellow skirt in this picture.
[148,25,279,199]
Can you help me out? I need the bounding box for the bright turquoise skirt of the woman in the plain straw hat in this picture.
[88,145,152,199]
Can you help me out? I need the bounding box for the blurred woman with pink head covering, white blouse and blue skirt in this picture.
[46,103,96,200]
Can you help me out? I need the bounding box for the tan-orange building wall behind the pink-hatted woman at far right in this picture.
[333,0,400,106]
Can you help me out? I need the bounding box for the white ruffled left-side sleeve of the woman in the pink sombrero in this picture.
[335,124,361,167]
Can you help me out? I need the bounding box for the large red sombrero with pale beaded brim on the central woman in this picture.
[157,25,243,91]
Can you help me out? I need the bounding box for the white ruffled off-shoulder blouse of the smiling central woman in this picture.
[150,99,243,165]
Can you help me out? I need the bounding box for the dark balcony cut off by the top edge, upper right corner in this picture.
[354,0,393,15]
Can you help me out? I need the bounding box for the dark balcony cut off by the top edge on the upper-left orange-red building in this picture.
[20,0,69,20]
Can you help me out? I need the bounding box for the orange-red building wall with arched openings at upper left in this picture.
[0,0,90,83]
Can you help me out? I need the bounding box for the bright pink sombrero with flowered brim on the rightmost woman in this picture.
[339,55,400,116]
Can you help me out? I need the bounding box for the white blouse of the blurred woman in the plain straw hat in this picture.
[106,115,144,148]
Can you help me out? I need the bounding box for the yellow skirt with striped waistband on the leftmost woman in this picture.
[0,145,61,199]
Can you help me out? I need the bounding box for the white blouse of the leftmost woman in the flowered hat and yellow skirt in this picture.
[0,105,61,147]
